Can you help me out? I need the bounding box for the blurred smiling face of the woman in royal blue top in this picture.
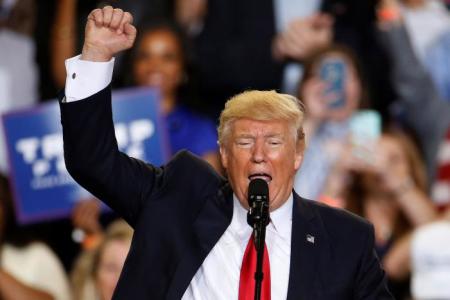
[133,29,184,97]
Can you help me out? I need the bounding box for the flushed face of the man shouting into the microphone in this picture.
[220,119,303,211]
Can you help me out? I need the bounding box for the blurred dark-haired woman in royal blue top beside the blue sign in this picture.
[132,23,221,170]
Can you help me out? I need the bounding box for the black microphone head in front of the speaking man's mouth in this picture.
[247,178,269,229]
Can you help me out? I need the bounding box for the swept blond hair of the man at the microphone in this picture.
[217,90,304,145]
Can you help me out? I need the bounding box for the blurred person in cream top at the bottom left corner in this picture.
[0,176,70,300]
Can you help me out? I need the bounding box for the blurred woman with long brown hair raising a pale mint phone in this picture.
[324,129,437,299]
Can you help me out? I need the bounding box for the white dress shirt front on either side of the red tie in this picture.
[182,194,293,300]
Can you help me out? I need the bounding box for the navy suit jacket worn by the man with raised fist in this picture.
[61,87,392,300]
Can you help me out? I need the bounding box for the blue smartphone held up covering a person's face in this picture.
[319,58,346,109]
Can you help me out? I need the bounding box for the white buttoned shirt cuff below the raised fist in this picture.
[65,55,114,102]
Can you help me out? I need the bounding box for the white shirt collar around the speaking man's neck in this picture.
[230,193,294,239]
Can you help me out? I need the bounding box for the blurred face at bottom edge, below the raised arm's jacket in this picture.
[96,239,130,300]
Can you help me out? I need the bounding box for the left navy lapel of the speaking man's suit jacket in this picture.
[167,184,233,299]
